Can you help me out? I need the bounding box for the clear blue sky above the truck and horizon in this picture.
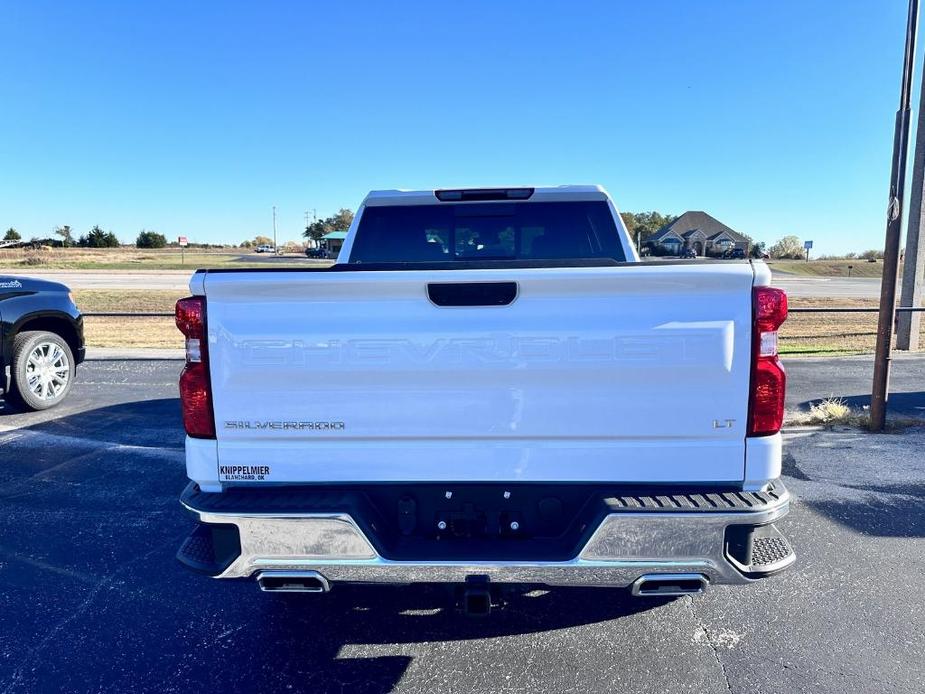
[0,0,918,253]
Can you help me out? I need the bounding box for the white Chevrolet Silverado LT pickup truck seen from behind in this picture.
[176,186,795,612]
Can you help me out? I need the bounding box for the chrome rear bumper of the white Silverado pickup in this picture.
[178,481,795,587]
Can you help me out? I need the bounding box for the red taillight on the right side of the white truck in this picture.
[748,287,787,436]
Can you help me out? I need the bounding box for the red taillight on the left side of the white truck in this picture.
[176,296,215,439]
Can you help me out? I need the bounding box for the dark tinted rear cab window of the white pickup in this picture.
[349,200,626,263]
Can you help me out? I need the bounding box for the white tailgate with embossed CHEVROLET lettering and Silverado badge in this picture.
[204,263,754,484]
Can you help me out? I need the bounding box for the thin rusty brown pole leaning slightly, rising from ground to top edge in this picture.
[870,0,919,431]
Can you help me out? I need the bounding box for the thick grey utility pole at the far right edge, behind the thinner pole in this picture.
[896,61,925,350]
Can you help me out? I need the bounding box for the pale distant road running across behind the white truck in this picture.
[0,269,880,298]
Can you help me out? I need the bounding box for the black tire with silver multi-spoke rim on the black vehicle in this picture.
[10,330,75,410]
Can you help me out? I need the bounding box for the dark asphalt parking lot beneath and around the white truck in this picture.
[0,360,925,694]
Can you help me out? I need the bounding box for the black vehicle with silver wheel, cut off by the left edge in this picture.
[0,275,85,410]
